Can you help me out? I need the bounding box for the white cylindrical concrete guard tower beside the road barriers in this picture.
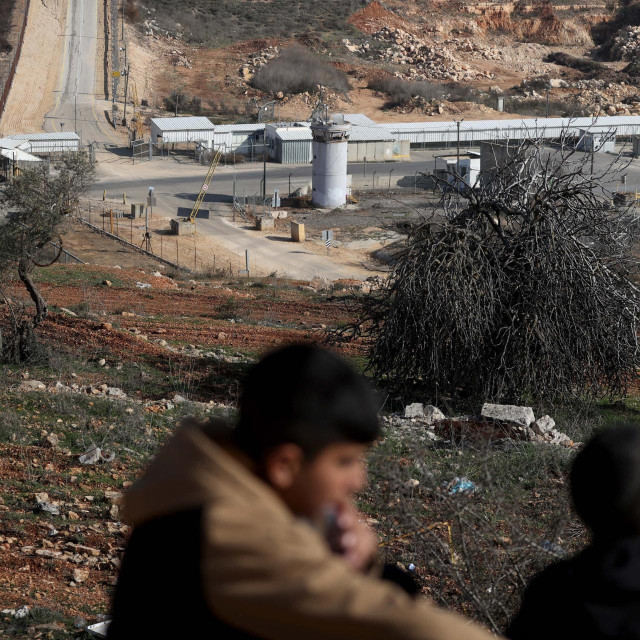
[311,114,351,208]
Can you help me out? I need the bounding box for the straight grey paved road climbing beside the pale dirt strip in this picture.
[45,0,117,144]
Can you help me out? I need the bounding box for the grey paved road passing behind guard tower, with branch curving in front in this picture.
[89,145,640,279]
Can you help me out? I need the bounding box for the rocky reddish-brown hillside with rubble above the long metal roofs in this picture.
[128,0,640,127]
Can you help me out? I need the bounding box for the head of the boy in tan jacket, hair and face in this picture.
[234,345,379,518]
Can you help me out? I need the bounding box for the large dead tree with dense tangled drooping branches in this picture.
[337,133,639,401]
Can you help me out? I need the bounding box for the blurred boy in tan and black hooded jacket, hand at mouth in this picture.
[109,346,490,640]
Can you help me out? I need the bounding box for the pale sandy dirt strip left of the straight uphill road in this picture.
[0,0,68,134]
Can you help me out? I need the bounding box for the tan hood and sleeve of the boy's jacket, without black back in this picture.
[124,426,493,640]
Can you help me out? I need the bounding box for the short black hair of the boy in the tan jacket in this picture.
[234,345,380,461]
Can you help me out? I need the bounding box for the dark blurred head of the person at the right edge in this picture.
[571,426,640,541]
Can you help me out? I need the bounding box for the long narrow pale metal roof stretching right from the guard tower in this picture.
[380,116,640,133]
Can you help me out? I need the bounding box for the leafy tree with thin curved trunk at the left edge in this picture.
[0,153,95,362]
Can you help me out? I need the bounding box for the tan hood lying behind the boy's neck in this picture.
[122,421,278,525]
